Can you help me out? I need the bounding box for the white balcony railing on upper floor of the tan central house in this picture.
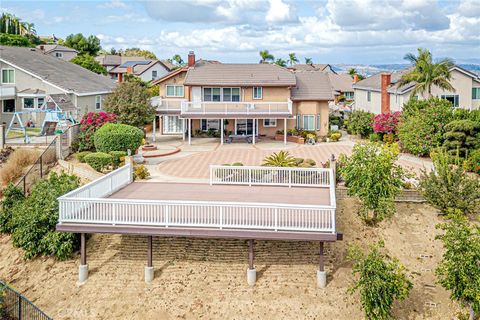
[182,101,292,115]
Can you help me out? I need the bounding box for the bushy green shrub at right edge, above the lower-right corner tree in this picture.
[419,150,480,214]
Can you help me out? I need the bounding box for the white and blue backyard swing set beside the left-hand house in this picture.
[6,94,77,143]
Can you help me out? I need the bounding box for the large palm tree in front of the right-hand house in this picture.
[397,48,455,98]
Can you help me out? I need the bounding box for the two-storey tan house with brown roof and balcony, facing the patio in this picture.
[153,52,334,142]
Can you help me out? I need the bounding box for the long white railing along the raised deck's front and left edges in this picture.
[58,165,336,233]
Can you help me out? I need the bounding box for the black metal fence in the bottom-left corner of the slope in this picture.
[0,281,52,320]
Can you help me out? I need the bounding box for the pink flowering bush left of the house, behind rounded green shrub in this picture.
[78,111,117,151]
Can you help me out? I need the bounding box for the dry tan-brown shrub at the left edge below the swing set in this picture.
[0,149,39,185]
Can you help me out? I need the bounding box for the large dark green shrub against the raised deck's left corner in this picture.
[12,172,79,259]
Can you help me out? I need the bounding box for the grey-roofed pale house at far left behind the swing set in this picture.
[0,46,116,124]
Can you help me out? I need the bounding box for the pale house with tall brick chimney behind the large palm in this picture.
[353,66,480,114]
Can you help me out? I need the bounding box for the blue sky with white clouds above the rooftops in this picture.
[0,0,480,64]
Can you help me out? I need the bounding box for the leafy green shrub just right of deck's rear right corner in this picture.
[341,142,405,225]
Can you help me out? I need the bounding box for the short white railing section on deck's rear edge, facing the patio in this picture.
[210,165,335,190]
